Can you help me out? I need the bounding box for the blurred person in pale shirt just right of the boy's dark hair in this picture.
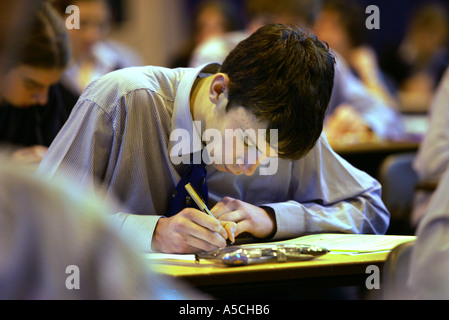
[313,0,404,146]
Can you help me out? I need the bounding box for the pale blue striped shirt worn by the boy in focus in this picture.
[38,64,389,251]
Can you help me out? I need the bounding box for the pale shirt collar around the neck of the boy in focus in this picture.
[169,63,220,157]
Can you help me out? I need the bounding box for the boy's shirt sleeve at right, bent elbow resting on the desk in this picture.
[260,135,390,239]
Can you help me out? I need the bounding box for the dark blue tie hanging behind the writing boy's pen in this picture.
[165,153,208,217]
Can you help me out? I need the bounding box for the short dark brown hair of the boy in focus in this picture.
[221,24,335,160]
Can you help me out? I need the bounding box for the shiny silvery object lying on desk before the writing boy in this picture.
[195,244,329,266]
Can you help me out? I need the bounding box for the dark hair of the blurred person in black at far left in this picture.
[7,2,70,69]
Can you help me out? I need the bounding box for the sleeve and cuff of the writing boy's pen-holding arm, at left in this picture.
[37,95,160,252]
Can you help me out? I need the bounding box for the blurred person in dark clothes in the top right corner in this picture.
[380,2,449,112]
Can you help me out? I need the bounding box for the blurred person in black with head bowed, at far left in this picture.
[0,4,78,168]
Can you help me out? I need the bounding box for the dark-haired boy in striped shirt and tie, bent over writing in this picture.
[39,24,389,253]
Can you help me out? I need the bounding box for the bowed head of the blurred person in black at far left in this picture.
[0,3,70,107]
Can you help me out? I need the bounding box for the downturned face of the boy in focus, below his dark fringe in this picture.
[203,104,277,176]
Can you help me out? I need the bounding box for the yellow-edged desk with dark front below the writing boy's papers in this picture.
[145,234,414,298]
